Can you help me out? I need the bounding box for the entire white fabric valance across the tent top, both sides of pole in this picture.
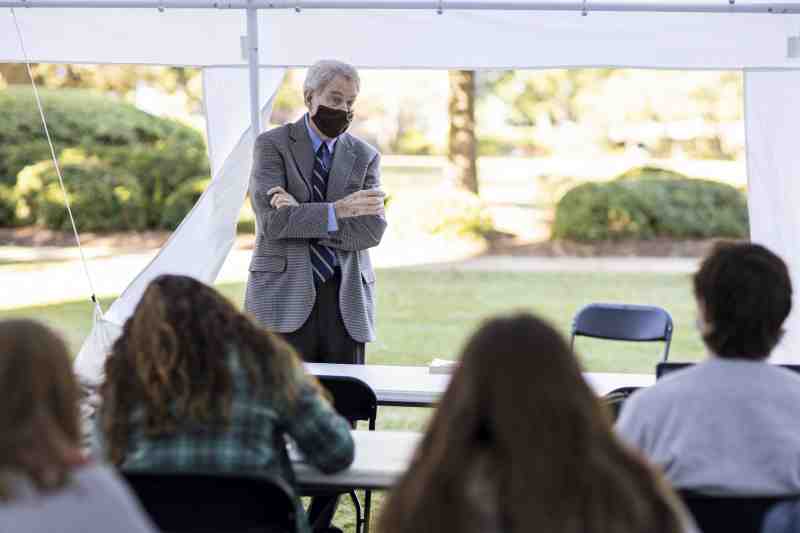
[0,4,800,69]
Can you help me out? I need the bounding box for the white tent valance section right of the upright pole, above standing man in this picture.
[259,10,800,69]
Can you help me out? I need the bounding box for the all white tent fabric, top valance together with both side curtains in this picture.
[0,0,800,380]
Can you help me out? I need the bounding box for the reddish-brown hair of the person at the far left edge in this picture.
[0,320,81,501]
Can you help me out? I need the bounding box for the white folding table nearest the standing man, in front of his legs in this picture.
[305,363,655,407]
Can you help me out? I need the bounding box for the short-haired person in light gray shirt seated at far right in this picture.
[617,242,800,496]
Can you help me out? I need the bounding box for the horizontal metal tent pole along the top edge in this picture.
[0,0,800,15]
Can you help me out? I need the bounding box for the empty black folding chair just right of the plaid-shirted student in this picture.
[317,376,378,533]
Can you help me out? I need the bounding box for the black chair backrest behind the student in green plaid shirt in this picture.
[122,471,297,533]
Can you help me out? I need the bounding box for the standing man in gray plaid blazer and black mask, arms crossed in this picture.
[245,61,386,363]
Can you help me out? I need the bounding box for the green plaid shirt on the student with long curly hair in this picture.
[105,352,355,533]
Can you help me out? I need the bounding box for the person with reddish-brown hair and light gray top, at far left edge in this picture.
[0,320,153,533]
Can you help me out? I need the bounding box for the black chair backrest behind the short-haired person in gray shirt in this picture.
[679,490,797,533]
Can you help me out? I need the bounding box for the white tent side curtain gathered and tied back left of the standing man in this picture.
[75,67,285,383]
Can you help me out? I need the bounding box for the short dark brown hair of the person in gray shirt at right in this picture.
[694,242,792,360]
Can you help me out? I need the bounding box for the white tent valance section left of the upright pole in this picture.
[0,8,247,65]
